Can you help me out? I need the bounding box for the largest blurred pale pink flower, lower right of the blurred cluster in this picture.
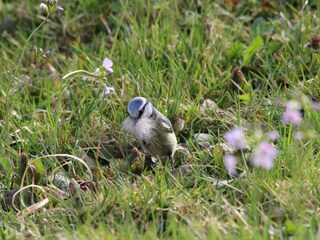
[252,142,278,170]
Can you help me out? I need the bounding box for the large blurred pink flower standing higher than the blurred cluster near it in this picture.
[282,100,302,125]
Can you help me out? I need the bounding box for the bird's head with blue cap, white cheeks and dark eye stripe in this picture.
[128,97,152,120]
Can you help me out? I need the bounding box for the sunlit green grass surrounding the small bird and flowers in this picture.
[0,0,320,239]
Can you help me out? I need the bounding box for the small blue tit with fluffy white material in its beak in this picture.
[123,97,177,168]
